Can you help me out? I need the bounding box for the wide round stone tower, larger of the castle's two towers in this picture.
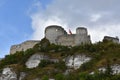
[45,25,67,44]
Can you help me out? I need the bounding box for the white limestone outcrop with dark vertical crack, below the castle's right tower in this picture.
[65,55,91,69]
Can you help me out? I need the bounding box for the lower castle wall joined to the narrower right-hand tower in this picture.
[57,27,91,46]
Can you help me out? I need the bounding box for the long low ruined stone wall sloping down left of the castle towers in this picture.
[10,40,40,54]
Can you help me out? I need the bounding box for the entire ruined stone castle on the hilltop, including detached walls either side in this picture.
[10,25,119,54]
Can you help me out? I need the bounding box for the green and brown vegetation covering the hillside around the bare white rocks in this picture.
[0,38,120,80]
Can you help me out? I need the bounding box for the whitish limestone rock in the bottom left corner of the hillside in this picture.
[0,68,17,80]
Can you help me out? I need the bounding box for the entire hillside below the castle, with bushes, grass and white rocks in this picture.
[0,40,120,80]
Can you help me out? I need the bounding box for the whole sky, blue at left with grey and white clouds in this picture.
[0,0,120,57]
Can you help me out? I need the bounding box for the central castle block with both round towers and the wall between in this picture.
[45,25,91,46]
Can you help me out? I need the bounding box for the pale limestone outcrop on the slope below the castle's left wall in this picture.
[25,53,47,68]
